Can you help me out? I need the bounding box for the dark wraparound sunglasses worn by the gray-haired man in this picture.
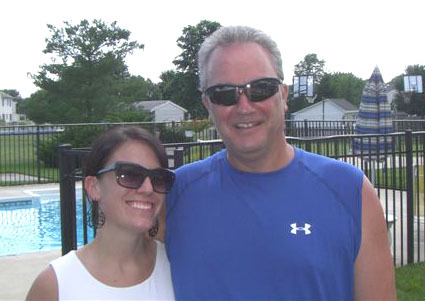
[204,77,282,106]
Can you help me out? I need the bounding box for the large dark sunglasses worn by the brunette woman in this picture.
[97,162,176,193]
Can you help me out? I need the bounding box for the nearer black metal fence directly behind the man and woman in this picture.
[59,131,425,265]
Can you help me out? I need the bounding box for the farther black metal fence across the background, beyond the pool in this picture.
[0,120,425,186]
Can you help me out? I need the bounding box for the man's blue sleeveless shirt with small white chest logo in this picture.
[166,148,363,300]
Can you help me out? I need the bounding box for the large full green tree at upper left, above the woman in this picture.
[28,20,143,123]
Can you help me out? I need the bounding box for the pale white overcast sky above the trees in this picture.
[0,0,425,98]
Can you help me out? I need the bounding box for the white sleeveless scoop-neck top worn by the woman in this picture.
[50,242,174,300]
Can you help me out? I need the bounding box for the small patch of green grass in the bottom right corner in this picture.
[395,262,425,300]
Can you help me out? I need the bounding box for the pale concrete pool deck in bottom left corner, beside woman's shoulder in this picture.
[0,250,61,300]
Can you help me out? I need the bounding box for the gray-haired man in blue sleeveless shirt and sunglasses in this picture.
[166,27,395,300]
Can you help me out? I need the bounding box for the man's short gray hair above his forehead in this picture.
[198,26,283,91]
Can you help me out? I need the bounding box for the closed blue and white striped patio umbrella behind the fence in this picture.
[354,67,393,160]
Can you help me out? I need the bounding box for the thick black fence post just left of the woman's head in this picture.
[58,144,77,255]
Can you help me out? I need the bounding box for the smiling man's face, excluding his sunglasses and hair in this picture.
[203,43,287,156]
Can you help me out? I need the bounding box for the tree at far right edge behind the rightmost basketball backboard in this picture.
[391,65,425,118]
